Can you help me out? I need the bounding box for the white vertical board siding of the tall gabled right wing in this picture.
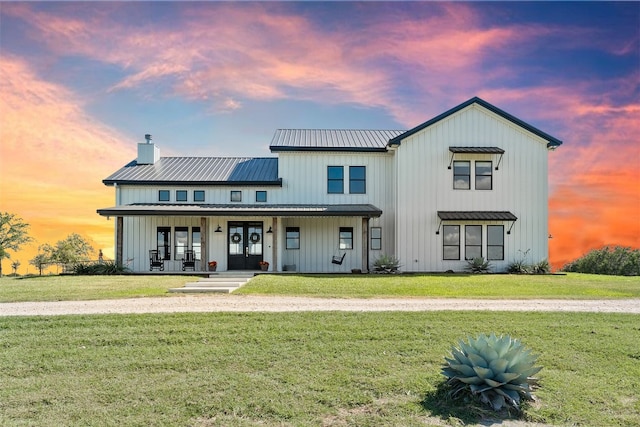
[395,104,548,271]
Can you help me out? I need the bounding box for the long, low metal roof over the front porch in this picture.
[97,203,382,218]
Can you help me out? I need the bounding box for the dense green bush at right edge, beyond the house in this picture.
[562,246,640,276]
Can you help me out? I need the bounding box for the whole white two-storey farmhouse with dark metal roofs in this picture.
[98,97,562,273]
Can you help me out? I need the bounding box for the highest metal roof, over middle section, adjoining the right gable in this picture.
[269,129,406,152]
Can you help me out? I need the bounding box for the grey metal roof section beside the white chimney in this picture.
[102,157,282,185]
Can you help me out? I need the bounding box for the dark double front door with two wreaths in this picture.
[227,222,263,270]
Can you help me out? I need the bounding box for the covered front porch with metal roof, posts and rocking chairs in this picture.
[98,204,382,274]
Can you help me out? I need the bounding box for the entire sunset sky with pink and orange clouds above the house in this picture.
[0,2,640,273]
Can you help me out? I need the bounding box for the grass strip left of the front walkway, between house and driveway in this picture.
[0,275,198,303]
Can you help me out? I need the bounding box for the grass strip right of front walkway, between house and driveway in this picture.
[235,273,640,299]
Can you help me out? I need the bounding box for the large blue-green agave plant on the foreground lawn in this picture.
[442,334,542,411]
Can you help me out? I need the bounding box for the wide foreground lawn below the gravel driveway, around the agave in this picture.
[0,312,640,426]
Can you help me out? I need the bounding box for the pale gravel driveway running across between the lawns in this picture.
[0,295,640,316]
